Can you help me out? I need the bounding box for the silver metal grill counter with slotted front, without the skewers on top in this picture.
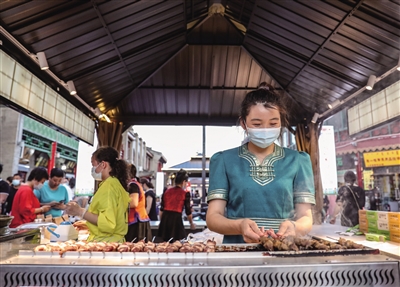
[0,226,400,286]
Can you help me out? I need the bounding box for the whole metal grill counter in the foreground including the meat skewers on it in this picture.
[0,217,400,286]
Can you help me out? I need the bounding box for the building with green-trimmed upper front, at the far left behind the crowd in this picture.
[0,106,79,179]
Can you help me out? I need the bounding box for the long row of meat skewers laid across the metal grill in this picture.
[25,237,379,257]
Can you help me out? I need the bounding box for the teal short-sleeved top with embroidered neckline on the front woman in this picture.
[207,143,315,243]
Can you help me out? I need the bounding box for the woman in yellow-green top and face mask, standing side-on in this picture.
[65,147,130,242]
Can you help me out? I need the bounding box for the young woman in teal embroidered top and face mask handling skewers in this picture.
[207,83,315,243]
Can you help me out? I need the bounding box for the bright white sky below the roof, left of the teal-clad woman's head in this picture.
[133,126,243,167]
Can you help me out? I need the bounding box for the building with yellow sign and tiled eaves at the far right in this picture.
[325,110,400,211]
